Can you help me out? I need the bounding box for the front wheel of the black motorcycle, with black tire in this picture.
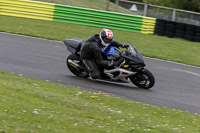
[129,69,155,89]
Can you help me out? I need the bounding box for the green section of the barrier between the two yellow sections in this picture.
[54,5,143,32]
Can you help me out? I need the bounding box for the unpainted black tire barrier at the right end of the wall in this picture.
[154,19,200,42]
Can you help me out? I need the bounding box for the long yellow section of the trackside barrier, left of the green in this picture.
[0,0,54,21]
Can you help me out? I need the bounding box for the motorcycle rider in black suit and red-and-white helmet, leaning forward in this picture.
[80,29,129,79]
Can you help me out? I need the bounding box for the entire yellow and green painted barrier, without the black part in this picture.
[0,0,156,34]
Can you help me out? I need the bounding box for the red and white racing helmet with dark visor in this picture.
[99,29,113,47]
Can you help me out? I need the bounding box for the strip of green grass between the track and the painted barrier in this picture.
[0,16,200,66]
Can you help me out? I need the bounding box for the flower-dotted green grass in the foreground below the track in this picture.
[0,72,200,133]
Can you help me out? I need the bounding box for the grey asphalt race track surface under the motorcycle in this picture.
[0,32,200,114]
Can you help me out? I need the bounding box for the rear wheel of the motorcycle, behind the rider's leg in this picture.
[66,54,89,78]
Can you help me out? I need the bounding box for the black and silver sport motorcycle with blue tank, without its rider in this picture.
[64,38,155,89]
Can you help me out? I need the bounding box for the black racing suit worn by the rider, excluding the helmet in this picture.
[80,34,124,79]
